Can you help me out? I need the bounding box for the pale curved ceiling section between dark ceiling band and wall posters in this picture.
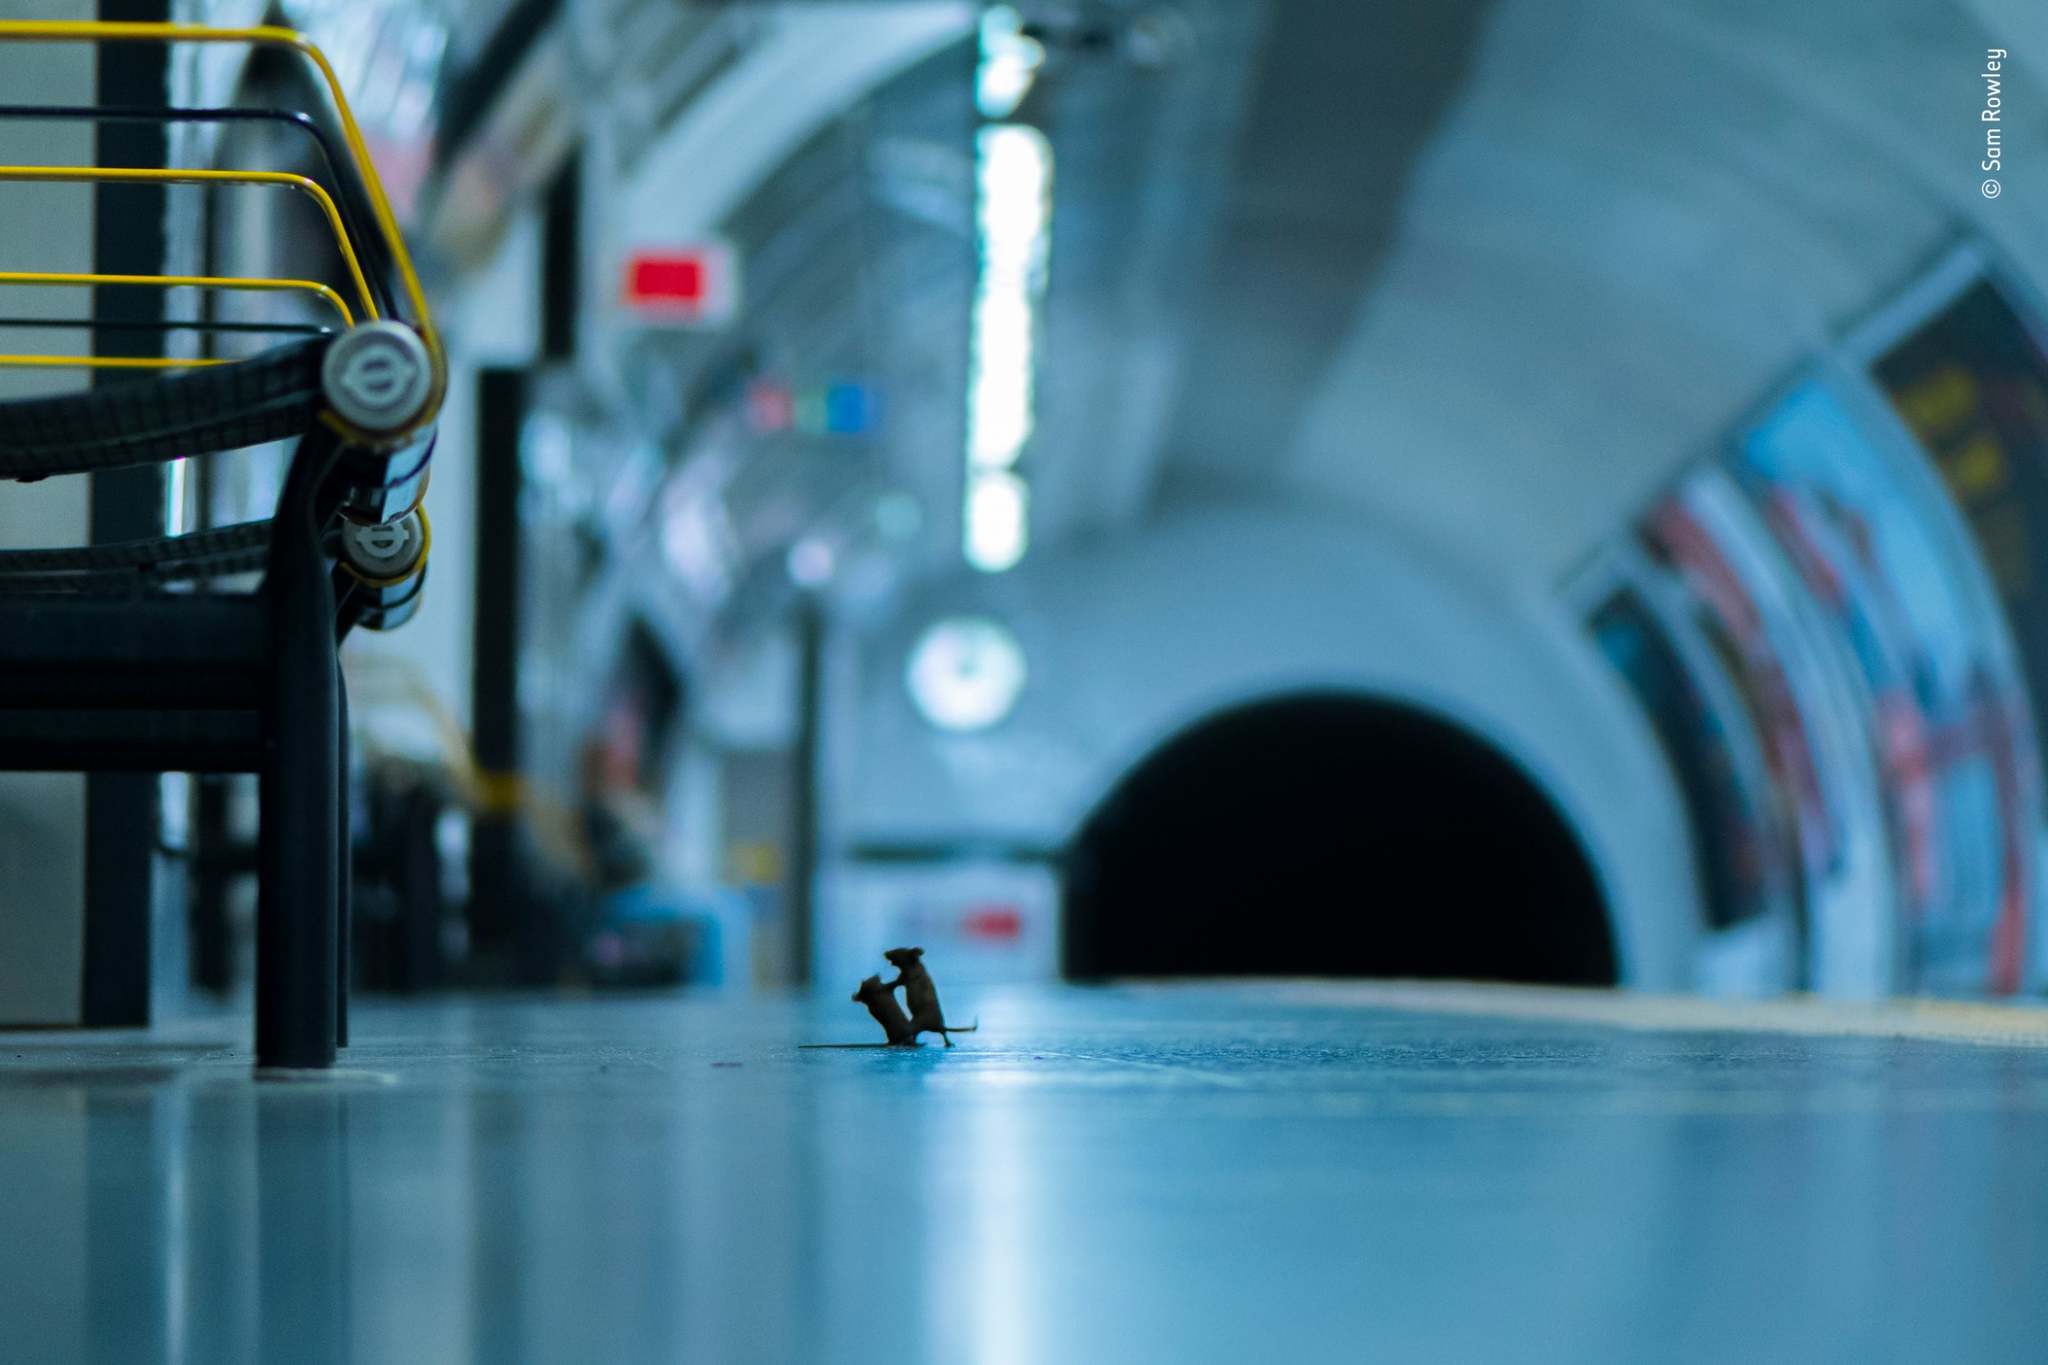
[1284,0,2048,581]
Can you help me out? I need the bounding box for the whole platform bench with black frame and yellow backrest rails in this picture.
[0,18,446,1068]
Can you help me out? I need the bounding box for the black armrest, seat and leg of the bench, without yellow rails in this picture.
[0,323,432,1068]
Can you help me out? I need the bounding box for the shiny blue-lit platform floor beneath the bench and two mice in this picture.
[0,982,2048,1365]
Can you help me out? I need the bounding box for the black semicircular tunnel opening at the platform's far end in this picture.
[1061,694,1616,986]
